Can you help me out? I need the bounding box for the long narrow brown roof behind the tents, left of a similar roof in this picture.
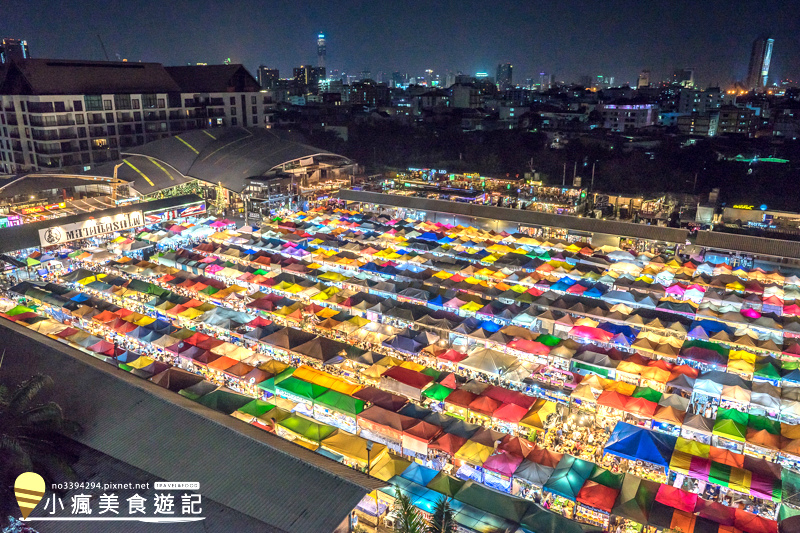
[339,189,689,244]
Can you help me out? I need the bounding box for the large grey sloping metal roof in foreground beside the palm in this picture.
[0,323,385,533]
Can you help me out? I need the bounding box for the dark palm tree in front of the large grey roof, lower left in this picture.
[0,374,81,521]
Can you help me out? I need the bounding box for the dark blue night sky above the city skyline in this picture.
[6,0,800,87]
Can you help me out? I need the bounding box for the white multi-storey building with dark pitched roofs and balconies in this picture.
[0,59,271,174]
